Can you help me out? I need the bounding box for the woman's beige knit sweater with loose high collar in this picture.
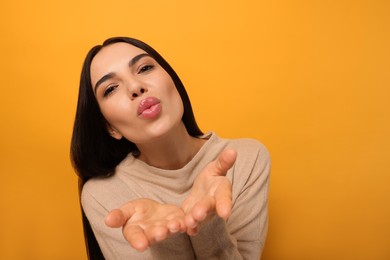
[81,133,270,260]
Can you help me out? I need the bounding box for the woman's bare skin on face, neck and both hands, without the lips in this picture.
[91,43,236,251]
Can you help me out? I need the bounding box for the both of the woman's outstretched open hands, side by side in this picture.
[105,150,236,252]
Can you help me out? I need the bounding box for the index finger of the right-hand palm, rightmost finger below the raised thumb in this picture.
[215,181,232,220]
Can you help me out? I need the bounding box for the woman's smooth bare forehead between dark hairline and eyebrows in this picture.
[91,42,146,82]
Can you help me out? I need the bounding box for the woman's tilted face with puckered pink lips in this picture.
[91,43,183,144]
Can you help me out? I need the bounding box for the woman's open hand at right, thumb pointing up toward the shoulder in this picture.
[182,150,237,235]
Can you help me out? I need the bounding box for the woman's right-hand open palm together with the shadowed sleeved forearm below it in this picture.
[182,149,242,260]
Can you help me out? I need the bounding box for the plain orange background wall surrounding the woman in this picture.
[0,0,390,260]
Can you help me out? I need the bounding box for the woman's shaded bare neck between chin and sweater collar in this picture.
[137,123,205,170]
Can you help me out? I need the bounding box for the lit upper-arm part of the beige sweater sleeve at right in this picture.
[227,142,270,259]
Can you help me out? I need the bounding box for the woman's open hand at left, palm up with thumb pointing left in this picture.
[105,199,186,252]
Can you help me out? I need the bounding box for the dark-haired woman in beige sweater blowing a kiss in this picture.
[71,37,269,259]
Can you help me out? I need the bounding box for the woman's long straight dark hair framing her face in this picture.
[70,37,203,259]
